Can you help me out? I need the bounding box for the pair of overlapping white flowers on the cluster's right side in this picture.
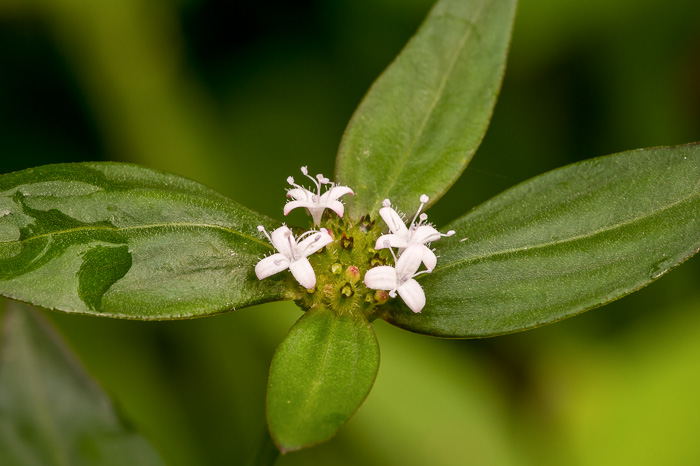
[364,194,455,313]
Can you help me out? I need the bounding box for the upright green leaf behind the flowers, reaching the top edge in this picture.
[336,0,516,218]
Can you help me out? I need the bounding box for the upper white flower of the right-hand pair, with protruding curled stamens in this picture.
[374,194,455,270]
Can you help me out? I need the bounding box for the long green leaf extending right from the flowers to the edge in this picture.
[384,144,700,338]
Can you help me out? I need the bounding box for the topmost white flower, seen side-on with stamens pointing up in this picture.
[284,167,355,225]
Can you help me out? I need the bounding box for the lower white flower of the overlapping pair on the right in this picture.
[364,245,430,313]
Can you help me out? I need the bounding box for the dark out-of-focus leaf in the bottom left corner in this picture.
[0,303,164,466]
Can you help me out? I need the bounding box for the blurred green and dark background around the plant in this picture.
[0,0,700,466]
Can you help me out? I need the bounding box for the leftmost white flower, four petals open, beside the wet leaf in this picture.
[255,225,333,289]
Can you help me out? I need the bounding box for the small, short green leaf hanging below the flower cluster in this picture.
[267,309,379,452]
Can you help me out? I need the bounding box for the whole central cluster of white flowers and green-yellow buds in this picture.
[255,167,455,313]
